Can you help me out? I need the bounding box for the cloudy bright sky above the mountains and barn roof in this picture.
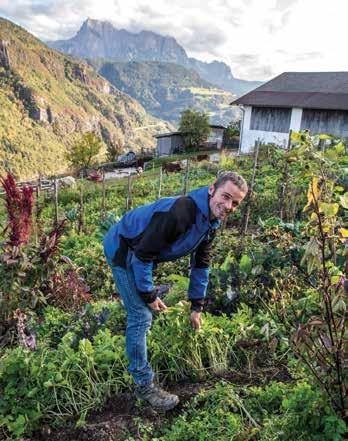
[0,0,348,81]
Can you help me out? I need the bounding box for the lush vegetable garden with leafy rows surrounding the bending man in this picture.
[0,133,348,441]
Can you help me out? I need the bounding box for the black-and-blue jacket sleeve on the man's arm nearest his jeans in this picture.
[131,197,197,303]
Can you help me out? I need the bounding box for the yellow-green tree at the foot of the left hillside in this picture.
[66,132,102,174]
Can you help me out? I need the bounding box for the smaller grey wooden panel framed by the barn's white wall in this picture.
[250,107,291,133]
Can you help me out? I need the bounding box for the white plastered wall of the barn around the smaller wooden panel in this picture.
[239,106,302,153]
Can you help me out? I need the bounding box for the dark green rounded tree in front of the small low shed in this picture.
[179,109,211,149]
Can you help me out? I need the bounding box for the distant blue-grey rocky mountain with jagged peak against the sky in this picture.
[47,18,262,96]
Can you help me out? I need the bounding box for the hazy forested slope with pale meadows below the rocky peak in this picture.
[88,60,240,126]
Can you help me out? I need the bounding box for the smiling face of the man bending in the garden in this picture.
[209,181,246,220]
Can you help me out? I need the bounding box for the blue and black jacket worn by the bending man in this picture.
[104,187,220,310]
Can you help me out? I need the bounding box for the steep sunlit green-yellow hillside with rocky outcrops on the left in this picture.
[0,18,170,178]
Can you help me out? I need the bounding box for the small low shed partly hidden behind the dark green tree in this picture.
[155,125,225,156]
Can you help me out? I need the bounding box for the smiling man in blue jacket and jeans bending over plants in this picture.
[104,172,248,410]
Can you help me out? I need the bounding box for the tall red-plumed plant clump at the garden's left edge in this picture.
[0,173,89,346]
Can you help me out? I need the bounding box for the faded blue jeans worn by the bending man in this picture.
[111,266,154,386]
